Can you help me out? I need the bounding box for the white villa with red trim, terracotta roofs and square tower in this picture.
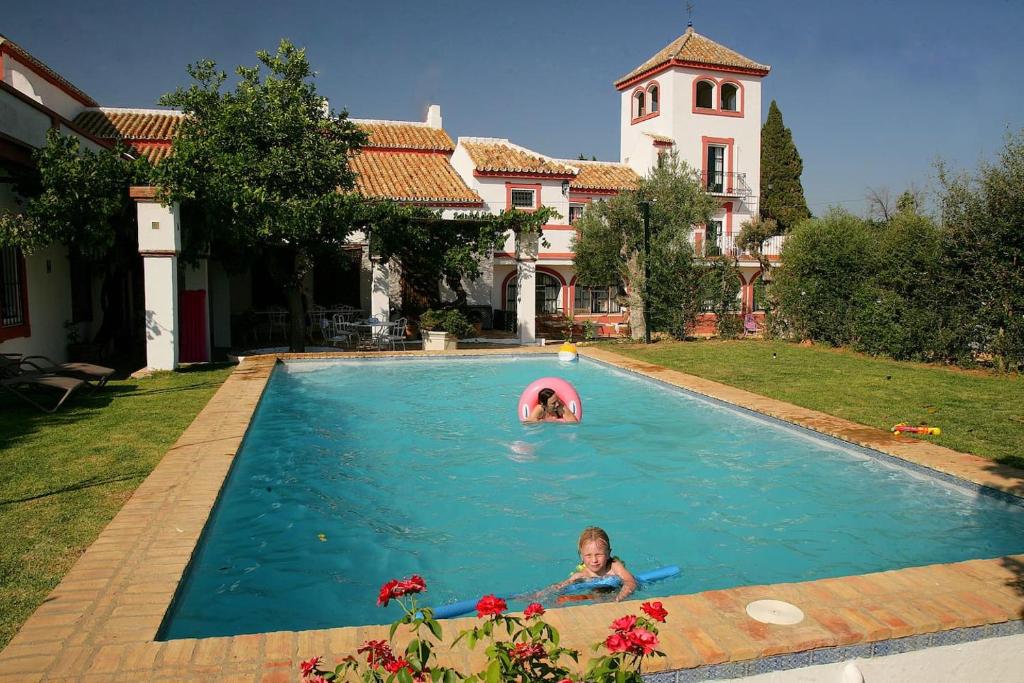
[0,28,779,368]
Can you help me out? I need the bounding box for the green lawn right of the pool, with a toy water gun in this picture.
[608,339,1024,467]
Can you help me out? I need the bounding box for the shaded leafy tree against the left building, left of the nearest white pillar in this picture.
[0,129,152,344]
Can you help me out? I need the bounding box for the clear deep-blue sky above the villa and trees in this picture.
[0,0,1024,213]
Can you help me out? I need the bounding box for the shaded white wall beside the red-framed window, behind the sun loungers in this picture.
[0,245,74,361]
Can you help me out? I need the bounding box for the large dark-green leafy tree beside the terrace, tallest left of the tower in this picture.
[158,40,366,350]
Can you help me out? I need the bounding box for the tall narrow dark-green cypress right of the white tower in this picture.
[761,99,811,232]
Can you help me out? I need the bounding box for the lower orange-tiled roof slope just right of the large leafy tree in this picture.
[350,152,482,204]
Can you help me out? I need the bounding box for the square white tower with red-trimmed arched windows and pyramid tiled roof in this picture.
[614,26,771,266]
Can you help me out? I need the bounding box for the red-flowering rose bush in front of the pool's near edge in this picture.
[299,575,669,683]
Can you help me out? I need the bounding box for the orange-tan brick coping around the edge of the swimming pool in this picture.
[0,348,1024,683]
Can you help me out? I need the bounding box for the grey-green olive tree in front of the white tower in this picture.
[573,155,718,339]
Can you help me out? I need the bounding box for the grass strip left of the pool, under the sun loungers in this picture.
[0,368,231,648]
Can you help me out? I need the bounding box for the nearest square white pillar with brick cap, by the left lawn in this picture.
[129,186,181,370]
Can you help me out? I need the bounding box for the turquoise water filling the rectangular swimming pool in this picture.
[163,356,1024,638]
